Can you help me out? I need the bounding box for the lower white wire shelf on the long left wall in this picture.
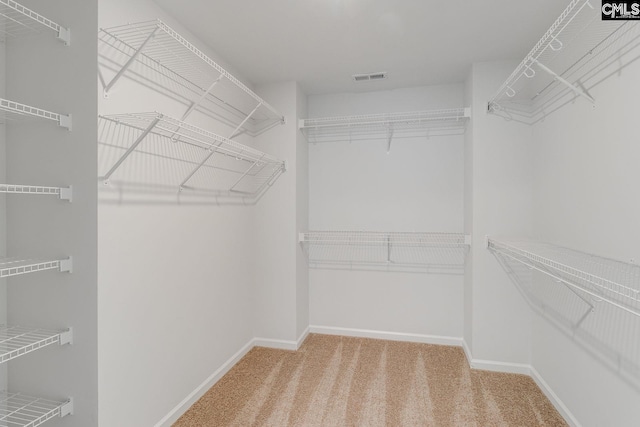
[100,112,286,198]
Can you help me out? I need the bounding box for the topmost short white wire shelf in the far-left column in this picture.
[0,0,71,45]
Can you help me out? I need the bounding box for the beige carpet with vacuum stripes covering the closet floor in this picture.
[174,334,567,427]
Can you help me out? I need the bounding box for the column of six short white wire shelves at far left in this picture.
[0,0,73,427]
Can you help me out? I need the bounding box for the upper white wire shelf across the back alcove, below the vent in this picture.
[298,108,471,149]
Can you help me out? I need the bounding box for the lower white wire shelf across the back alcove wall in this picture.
[299,231,470,272]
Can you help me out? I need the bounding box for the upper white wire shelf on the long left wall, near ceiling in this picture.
[99,20,284,138]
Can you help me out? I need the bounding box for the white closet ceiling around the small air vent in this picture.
[155,0,568,94]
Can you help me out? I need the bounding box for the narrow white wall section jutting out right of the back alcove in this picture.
[471,61,533,364]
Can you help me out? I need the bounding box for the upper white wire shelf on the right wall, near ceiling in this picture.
[488,0,640,124]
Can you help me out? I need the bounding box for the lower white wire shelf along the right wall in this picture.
[487,238,640,316]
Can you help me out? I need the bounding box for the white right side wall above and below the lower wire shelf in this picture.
[533,49,640,427]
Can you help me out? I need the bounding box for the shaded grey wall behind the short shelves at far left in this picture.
[6,0,99,427]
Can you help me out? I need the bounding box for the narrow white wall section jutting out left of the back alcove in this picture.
[253,82,307,346]
